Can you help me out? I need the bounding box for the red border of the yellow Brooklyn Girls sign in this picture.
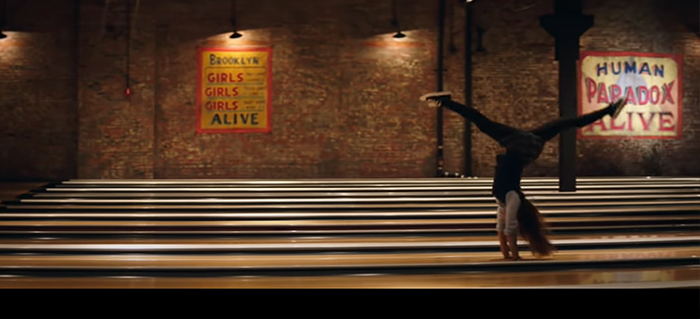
[197,46,272,134]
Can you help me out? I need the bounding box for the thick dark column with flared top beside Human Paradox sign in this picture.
[540,0,593,192]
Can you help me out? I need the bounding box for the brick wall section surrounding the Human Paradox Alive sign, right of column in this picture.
[577,0,700,175]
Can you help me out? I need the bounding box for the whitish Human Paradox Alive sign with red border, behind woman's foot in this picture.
[578,52,683,139]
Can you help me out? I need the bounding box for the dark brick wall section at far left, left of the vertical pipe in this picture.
[0,0,77,180]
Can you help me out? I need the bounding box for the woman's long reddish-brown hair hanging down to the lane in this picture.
[518,199,556,256]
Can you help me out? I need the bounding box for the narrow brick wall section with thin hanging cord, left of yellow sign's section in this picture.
[77,0,157,178]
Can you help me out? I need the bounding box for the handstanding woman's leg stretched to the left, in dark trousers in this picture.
[421,92,519,143]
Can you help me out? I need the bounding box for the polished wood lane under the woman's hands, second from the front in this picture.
[0,247,700,272]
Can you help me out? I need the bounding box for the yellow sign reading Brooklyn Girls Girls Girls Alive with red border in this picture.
[197,47,272,133]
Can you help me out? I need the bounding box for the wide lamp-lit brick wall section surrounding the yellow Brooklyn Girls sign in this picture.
[149,0,437,178]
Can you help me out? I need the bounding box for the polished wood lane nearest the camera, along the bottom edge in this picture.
[0,266,700,289]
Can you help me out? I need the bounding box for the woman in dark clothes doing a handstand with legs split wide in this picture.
[421,92,626,260]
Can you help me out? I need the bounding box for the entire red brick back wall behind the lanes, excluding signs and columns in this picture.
[0,0,700,179]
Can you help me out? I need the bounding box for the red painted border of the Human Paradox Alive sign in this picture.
[576,51,683,140]
